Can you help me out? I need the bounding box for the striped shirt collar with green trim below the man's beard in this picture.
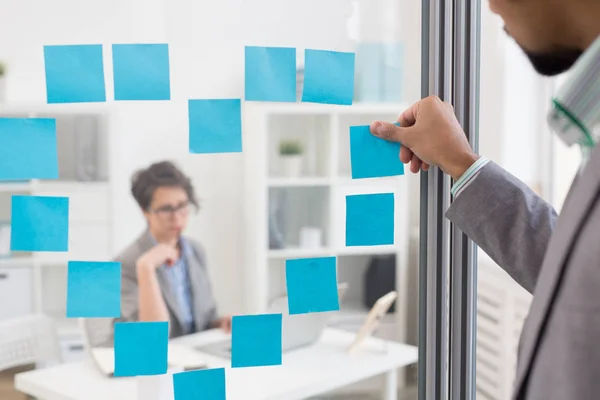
[548,37,600,157]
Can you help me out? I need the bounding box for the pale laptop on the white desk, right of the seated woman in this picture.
[196,282,348,358]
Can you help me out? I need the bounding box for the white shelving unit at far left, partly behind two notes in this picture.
[0,104,112,360]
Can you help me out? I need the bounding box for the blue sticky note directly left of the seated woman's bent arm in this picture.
[67,261,121,318]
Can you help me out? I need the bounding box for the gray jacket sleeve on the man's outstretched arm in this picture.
[446,162,557,293]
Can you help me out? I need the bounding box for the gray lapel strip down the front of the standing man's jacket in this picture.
[515,146,600,398]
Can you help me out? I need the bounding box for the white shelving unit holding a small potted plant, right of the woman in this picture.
[243,103,409,341]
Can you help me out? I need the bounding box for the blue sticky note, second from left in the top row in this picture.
[112,44,171,100]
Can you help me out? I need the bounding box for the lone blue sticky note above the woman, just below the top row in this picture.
[188,99,242,154]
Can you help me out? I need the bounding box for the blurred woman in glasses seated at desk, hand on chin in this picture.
[114,161,231,337]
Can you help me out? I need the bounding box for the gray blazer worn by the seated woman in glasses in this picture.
[87,231,217,346]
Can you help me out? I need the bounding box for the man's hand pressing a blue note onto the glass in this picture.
[371,96,479,180]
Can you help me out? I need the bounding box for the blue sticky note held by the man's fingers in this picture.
[350,125,404,179]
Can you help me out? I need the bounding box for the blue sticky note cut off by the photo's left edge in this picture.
[0,118,58,181]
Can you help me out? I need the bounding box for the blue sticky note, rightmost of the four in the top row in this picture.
[302,49,355,105]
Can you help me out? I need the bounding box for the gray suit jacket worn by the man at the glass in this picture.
[446,151,600,400]
